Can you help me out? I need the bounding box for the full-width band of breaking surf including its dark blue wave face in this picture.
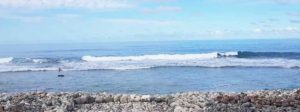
[0,51,300,72]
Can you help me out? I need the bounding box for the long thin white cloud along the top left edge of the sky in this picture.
[0,0,132,9]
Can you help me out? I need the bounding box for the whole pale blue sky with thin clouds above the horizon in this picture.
[0,0,300,44]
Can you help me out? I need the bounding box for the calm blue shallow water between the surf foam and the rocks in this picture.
[0,67,300,94]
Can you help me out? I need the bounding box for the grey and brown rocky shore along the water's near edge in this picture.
[0,89,300,112]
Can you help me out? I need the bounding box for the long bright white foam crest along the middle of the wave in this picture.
[81,52,218,62]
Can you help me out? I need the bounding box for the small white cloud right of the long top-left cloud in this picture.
[142,6,182,13]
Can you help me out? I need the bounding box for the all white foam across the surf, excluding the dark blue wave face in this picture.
[0,52,300,72]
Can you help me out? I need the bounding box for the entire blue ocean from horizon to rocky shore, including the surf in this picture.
[0,39,300,94]
